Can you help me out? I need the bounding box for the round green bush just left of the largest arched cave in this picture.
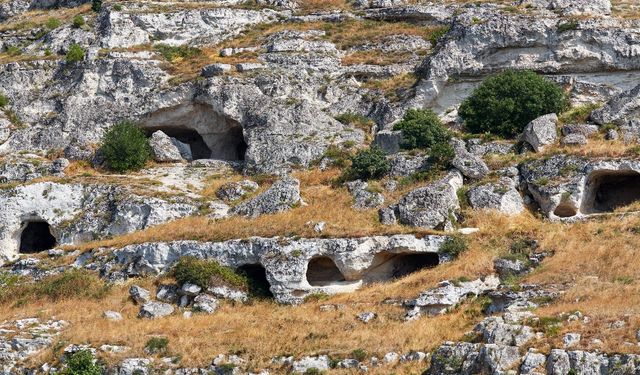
[102,121,151,172]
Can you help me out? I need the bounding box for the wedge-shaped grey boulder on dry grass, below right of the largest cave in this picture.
[231,177,301,217]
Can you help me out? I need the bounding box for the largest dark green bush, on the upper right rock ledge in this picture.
[459,70,568,138]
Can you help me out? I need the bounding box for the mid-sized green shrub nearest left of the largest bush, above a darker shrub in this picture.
[393,109,451,150]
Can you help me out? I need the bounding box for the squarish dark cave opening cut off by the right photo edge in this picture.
[582,170,640,213]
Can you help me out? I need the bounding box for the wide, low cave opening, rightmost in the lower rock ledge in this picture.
[364,252,440,282]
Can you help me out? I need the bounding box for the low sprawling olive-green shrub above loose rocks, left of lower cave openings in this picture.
[172,257,249,289]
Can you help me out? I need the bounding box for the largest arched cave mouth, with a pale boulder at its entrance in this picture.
[140,103,247,161]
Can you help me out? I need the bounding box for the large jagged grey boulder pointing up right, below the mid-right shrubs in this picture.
[393,171,463,230]
